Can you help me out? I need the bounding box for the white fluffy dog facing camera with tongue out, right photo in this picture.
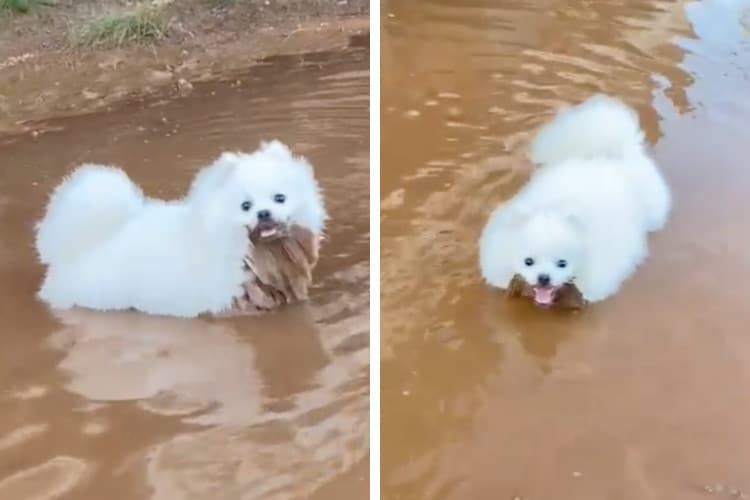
[479,95,671,306]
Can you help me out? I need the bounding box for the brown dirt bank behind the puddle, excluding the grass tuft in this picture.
[0,0,369,136]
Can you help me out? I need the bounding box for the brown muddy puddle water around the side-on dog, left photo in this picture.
[0,50,369,500]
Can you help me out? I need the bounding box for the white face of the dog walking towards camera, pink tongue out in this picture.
[512,212,583,307]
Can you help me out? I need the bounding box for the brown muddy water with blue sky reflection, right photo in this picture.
[381,0,750,500]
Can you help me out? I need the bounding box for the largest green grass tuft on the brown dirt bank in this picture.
[71,0,169,46]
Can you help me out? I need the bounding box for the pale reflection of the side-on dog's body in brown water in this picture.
[50,311,264,425]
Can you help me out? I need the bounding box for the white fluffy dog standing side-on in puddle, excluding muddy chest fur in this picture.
[36,141,326,317]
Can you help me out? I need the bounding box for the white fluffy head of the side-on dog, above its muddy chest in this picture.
[198,141,325,241]
